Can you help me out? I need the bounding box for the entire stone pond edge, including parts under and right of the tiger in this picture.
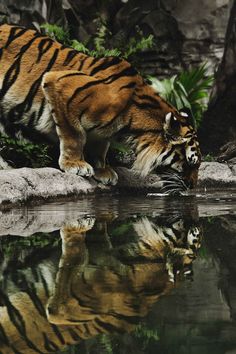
[0,162,236,206]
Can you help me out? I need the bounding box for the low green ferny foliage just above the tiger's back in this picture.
[41,21,154,59]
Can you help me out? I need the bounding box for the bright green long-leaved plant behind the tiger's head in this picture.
[150,64,213,127]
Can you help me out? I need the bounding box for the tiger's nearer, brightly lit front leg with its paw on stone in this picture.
[42,72,94,177]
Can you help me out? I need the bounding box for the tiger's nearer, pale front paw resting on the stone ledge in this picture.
[59,160,94,177]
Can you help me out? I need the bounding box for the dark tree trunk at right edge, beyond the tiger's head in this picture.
[199,0,236,159]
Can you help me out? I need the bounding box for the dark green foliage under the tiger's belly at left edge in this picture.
[0,135,52,168]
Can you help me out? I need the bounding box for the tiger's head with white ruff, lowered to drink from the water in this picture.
[121,79,201,189]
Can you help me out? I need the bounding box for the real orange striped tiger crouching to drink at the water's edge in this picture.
[0,24,201,188]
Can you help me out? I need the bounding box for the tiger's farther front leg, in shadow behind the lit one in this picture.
[86,139,118,186]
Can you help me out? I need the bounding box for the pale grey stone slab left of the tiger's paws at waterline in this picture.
[0,168,96,205]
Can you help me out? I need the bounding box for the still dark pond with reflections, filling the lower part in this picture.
[0,190,236,354]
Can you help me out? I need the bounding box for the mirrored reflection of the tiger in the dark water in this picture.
[0,217,201,354]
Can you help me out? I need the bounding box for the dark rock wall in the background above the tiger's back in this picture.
[0,0,232,77]
